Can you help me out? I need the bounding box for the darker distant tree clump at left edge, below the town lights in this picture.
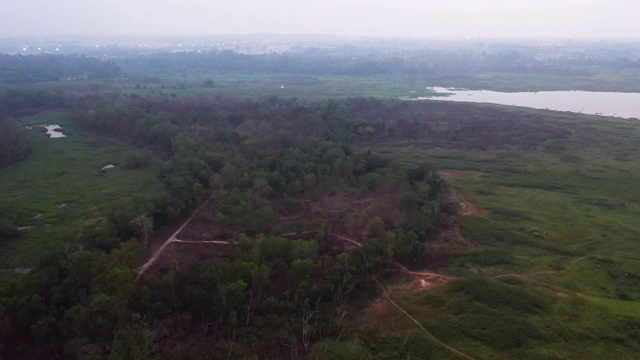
[0,54,120,84]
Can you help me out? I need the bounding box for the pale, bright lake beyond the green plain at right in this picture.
[417,87,640,119]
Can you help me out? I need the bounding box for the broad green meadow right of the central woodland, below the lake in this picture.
[342,105,640,359]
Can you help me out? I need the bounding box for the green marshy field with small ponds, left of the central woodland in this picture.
[0,112,160,280]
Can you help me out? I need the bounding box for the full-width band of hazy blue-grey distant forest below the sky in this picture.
[0,43,640,84]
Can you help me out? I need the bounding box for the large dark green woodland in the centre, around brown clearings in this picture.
[0,95,450,359]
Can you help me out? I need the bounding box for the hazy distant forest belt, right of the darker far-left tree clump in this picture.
[117,46,640,76]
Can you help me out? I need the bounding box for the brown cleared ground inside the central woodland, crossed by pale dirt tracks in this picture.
[134,184,400,278]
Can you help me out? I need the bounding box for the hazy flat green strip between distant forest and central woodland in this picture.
[11,68,640,99]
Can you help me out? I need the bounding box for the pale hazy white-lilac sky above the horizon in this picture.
[0,0,640,38]
